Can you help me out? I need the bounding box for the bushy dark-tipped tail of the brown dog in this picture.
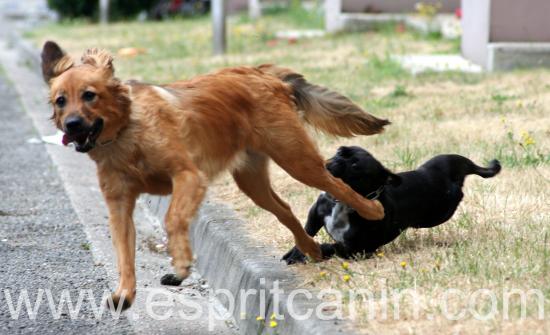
[259,65,390,137]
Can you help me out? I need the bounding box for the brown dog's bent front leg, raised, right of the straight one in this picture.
[161,170,207,285]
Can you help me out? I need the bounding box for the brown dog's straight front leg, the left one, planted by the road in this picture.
[105,192,137,310]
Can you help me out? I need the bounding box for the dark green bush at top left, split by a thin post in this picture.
[48,0,159,20]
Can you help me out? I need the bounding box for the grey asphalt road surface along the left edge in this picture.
[0,75,136,334]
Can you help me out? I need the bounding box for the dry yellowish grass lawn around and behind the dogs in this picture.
[30,9,550,334]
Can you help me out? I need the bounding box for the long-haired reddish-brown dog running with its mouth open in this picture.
[42,42,389,308]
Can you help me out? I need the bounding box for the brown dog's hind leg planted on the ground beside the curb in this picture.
[233,153,321,260]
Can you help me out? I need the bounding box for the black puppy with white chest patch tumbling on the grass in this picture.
[283,147,501,264]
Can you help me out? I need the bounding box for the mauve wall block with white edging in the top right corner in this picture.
[462,0,550,71]
